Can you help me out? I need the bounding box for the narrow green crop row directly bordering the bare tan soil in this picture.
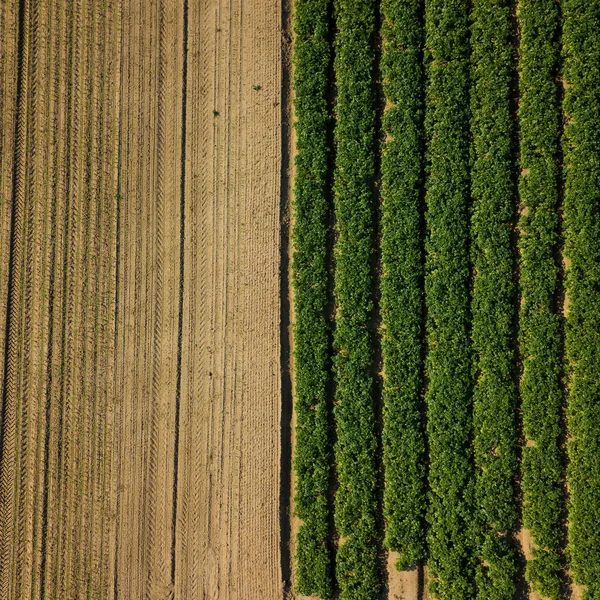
[292,0,332,598]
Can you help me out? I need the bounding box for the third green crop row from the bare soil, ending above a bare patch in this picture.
[381,0,425,569]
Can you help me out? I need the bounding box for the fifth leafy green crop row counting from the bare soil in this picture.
[471,0,516,600]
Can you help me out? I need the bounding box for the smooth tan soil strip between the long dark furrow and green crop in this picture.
[175,1,281,598]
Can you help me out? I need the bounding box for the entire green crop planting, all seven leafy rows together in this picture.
[293,0,600,600]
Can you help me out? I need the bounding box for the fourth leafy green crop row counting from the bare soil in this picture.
[425,0,474,600]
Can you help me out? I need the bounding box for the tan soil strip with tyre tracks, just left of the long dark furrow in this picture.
[116,1,182,597]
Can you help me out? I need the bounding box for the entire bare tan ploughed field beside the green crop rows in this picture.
[0,0,283,600]
